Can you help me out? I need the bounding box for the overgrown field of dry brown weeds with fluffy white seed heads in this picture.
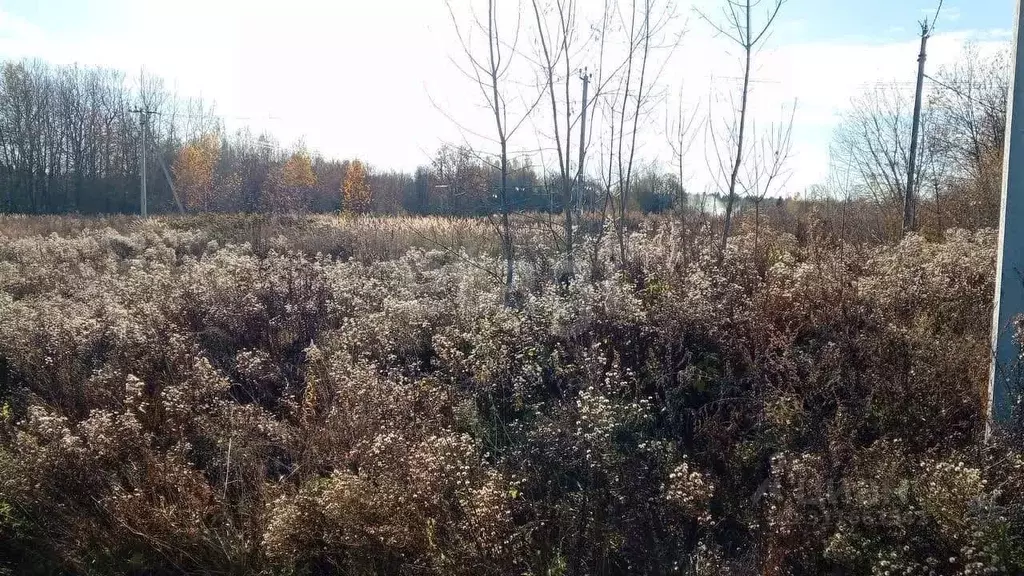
[0,216,1024,576]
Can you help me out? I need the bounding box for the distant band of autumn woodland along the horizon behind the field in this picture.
[0,37,1009,224]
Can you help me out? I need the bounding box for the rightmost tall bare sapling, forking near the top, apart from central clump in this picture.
[698,0,785,253]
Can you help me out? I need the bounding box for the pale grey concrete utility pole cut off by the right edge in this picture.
[988,0,1024,423]
